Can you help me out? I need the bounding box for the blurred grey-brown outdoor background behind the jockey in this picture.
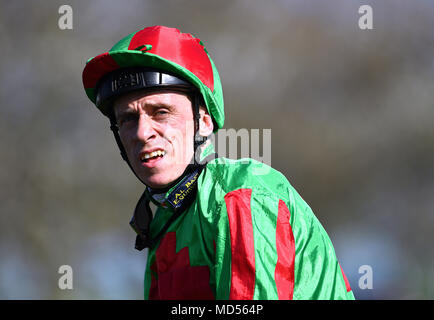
[0,0,434,299]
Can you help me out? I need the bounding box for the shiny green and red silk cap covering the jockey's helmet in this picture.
[83,26,225,131]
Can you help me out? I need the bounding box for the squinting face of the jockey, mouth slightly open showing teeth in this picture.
[114,91,194,188]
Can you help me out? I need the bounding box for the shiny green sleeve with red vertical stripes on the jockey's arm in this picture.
[200,160,354,300]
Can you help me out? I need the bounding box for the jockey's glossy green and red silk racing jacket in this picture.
[145,145,354,300]
